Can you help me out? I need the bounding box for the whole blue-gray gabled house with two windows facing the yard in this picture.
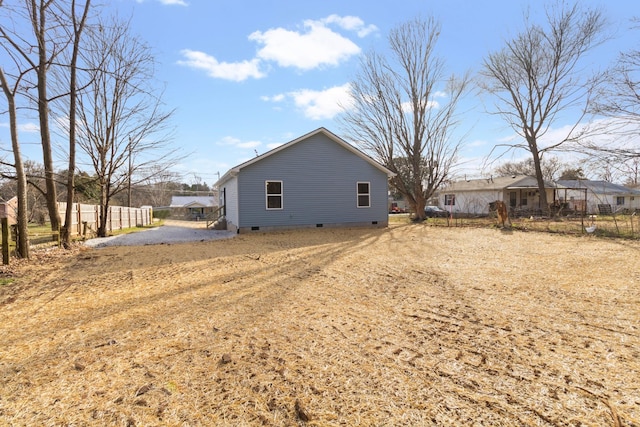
[215,128,393,233]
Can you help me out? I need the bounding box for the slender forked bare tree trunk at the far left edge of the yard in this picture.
[0,67,29,258]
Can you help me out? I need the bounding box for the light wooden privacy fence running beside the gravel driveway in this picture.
[58,202,153,237]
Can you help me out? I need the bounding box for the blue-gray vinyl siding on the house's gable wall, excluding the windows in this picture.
[238,134,388,228]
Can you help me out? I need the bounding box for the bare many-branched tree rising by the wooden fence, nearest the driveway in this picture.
[77,16,180,237]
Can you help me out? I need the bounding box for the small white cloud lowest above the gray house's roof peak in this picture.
[288,83,353,120]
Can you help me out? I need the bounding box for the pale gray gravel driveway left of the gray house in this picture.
[84,220,236,248]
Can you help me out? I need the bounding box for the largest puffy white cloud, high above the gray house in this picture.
[249,15,360,70]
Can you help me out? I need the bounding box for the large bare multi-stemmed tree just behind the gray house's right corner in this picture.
[341,18,469,220]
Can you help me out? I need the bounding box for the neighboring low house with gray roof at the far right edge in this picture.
[556,180,640,214]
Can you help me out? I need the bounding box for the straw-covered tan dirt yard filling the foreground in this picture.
[0,224,640,426]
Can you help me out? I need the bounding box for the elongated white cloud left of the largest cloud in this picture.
[178,49,266,82]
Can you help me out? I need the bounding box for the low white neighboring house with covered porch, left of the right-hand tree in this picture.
[438,175,555,215]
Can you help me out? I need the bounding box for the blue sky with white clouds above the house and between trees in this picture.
[0,0,640,184]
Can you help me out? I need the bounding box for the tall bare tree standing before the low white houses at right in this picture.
[481,1,605,211]
